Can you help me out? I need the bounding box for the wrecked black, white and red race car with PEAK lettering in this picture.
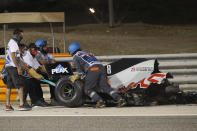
[46,58,197,107]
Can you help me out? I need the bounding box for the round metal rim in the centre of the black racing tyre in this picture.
[61,83,75,100]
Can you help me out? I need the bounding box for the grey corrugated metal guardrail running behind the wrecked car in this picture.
[0,53,197,99]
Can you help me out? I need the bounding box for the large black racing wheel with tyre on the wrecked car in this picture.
[55,76,84,107]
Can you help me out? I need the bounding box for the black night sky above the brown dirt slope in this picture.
[0,0,197,25]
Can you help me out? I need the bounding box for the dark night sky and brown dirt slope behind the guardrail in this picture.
[0,0,197,55]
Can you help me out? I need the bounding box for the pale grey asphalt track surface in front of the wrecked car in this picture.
[0,104,197,131]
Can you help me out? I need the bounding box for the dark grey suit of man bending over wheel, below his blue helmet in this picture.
[73,51,125,107]
